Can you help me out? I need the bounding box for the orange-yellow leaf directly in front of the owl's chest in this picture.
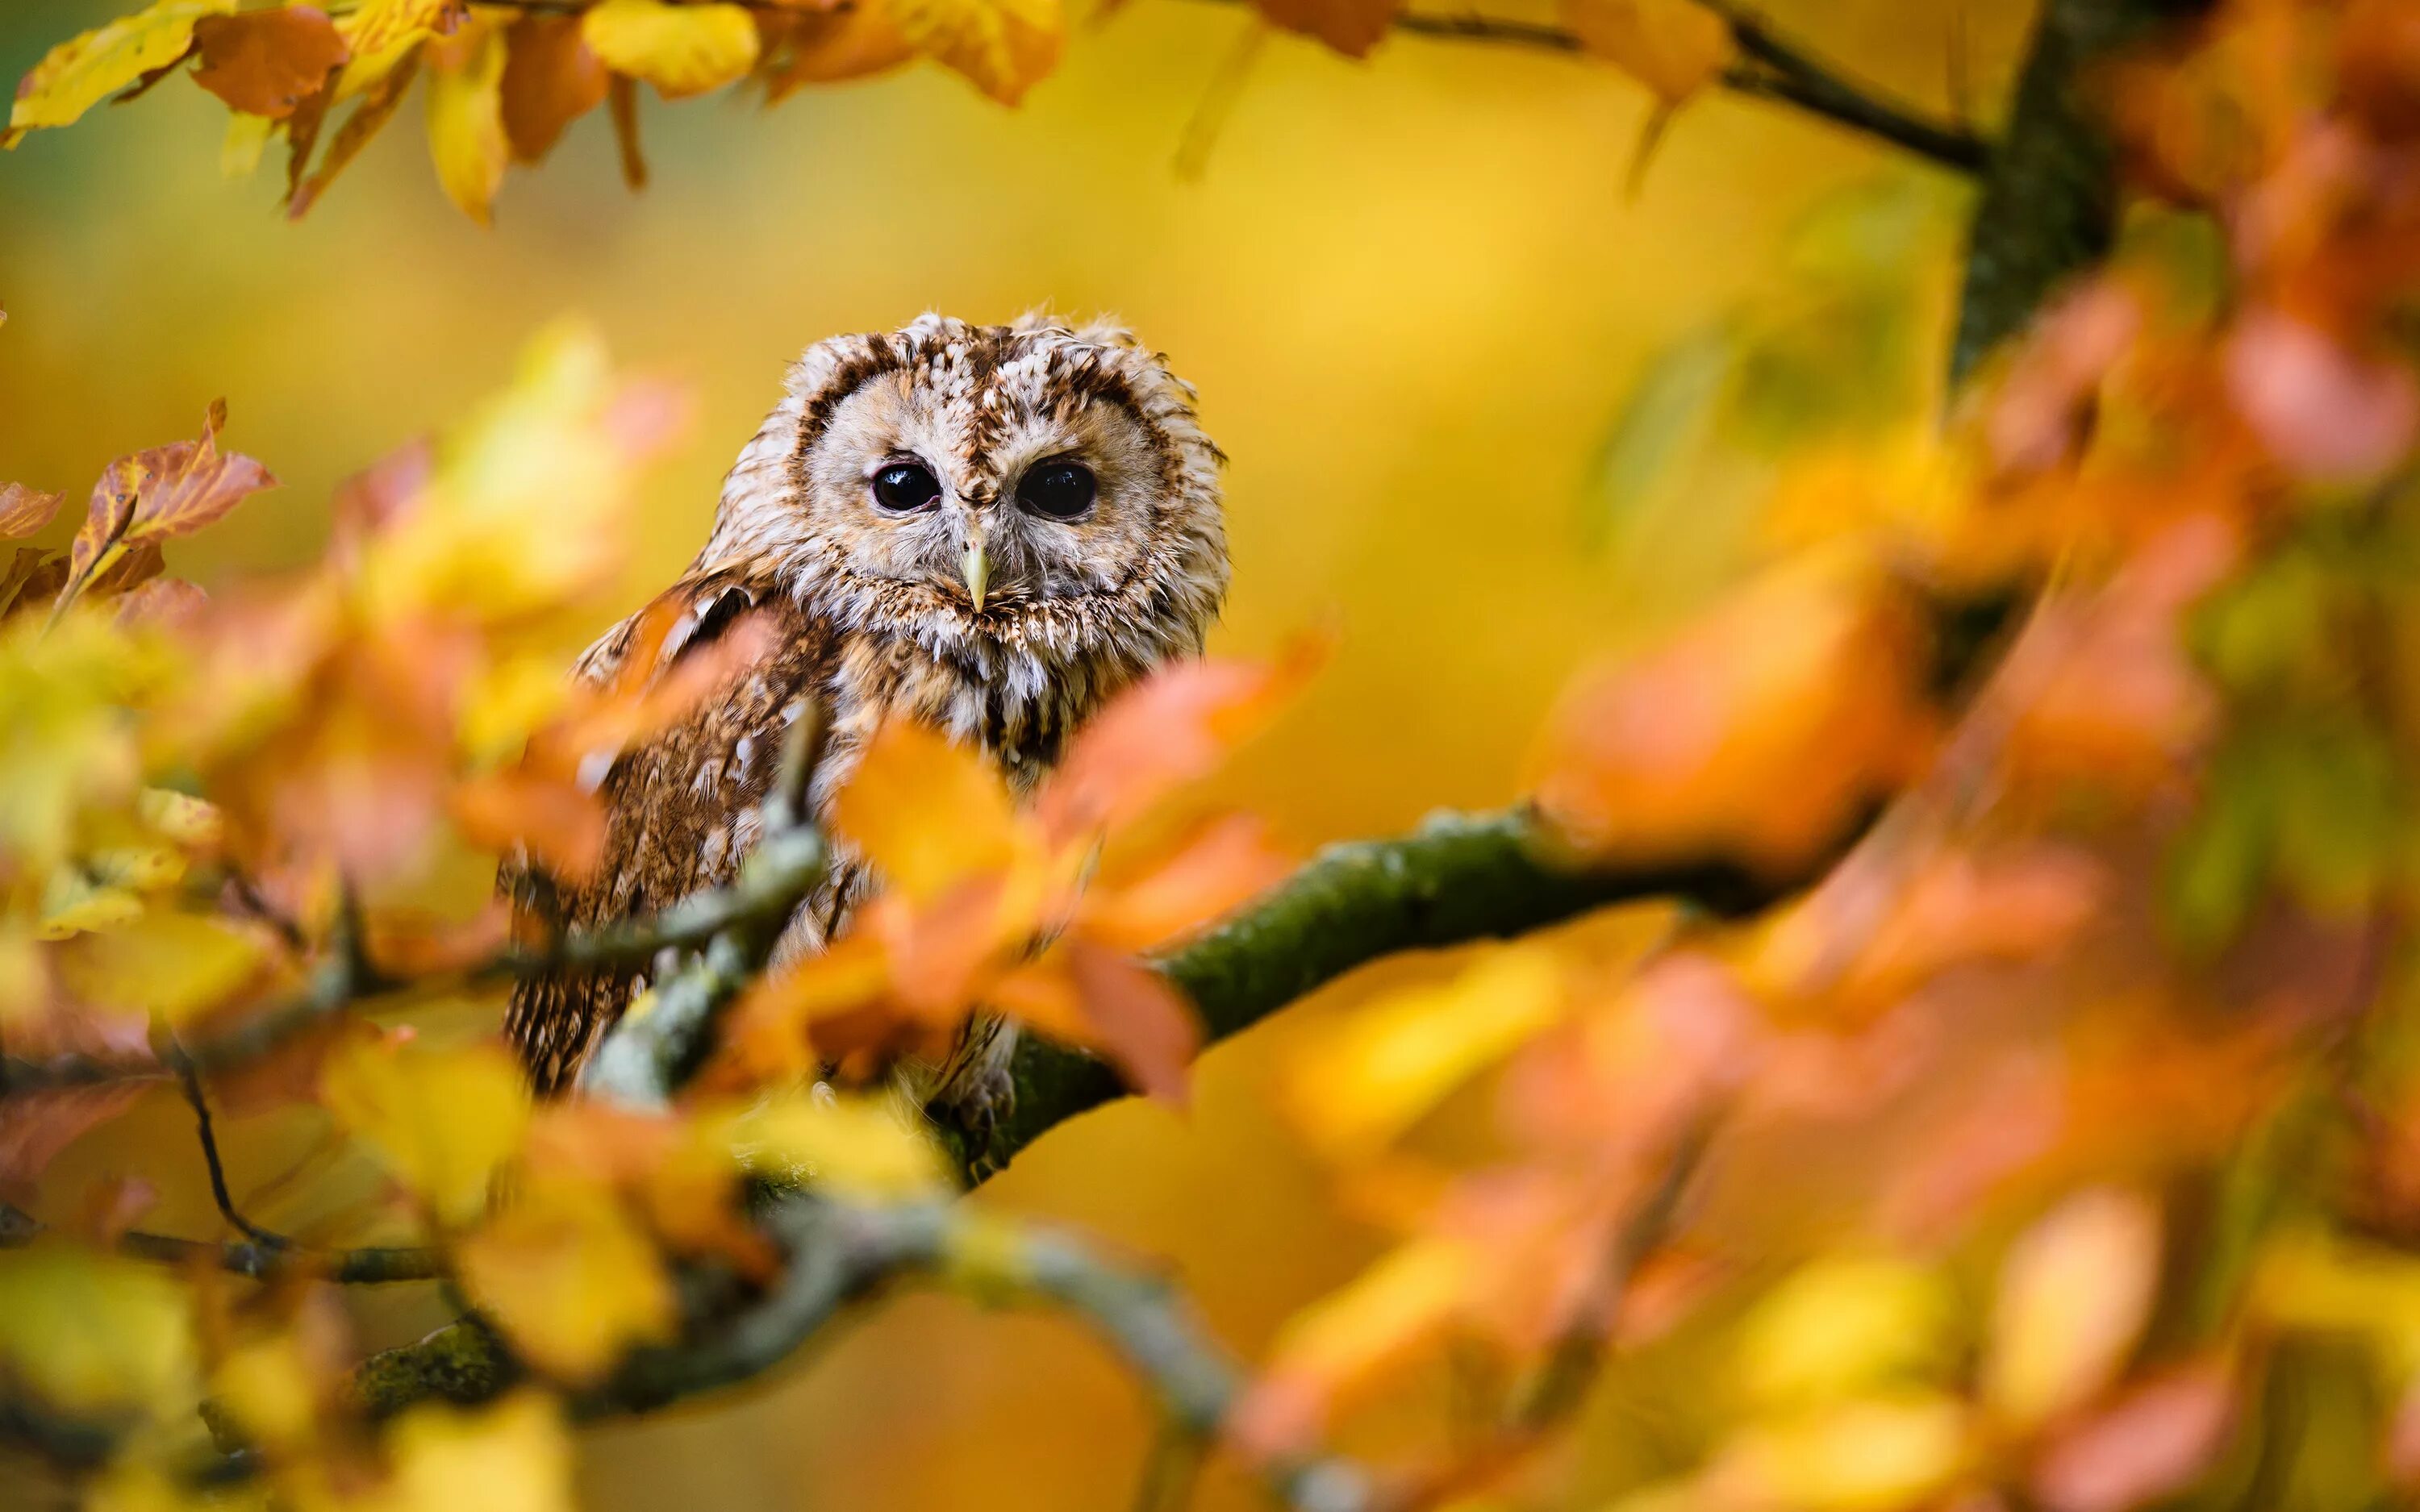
[832,719,1019,902]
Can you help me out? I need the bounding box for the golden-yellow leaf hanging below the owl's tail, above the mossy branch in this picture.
[455,1178,675,1384]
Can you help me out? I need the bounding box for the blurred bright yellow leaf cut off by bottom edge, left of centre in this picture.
[378,1391,578,1512]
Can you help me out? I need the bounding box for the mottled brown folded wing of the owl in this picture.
[499,569,828,1096]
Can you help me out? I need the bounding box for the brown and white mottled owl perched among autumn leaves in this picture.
[506,314,1227,1115]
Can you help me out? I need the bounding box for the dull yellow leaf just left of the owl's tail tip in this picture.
[319,1040,530,1224]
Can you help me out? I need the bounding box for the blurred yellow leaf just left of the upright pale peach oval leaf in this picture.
[1738,1258,1958,1408]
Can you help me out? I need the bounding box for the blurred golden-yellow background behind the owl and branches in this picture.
[0,0,2030,1512]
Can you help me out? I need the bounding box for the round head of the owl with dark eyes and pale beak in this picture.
[699,314,1227,680]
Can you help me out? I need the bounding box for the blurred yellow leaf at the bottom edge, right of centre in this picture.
[1704,1396,1970,1512]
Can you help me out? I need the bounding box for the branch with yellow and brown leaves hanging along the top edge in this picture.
[0,0,1989,223]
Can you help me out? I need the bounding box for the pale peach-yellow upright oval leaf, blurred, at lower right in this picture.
[1982,1188,2161,1430]
